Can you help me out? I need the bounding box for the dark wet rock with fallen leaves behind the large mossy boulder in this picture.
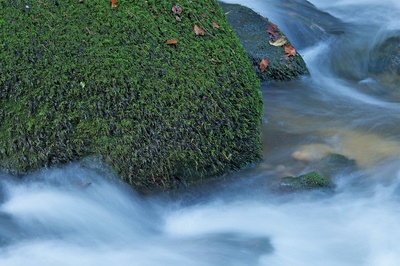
[219,2,309,81]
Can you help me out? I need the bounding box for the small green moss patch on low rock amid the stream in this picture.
[282,172,332,189]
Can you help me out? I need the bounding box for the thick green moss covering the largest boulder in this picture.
[0,0,262,189]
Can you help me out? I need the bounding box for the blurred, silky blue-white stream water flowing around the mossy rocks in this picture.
[0,0,400,266]
